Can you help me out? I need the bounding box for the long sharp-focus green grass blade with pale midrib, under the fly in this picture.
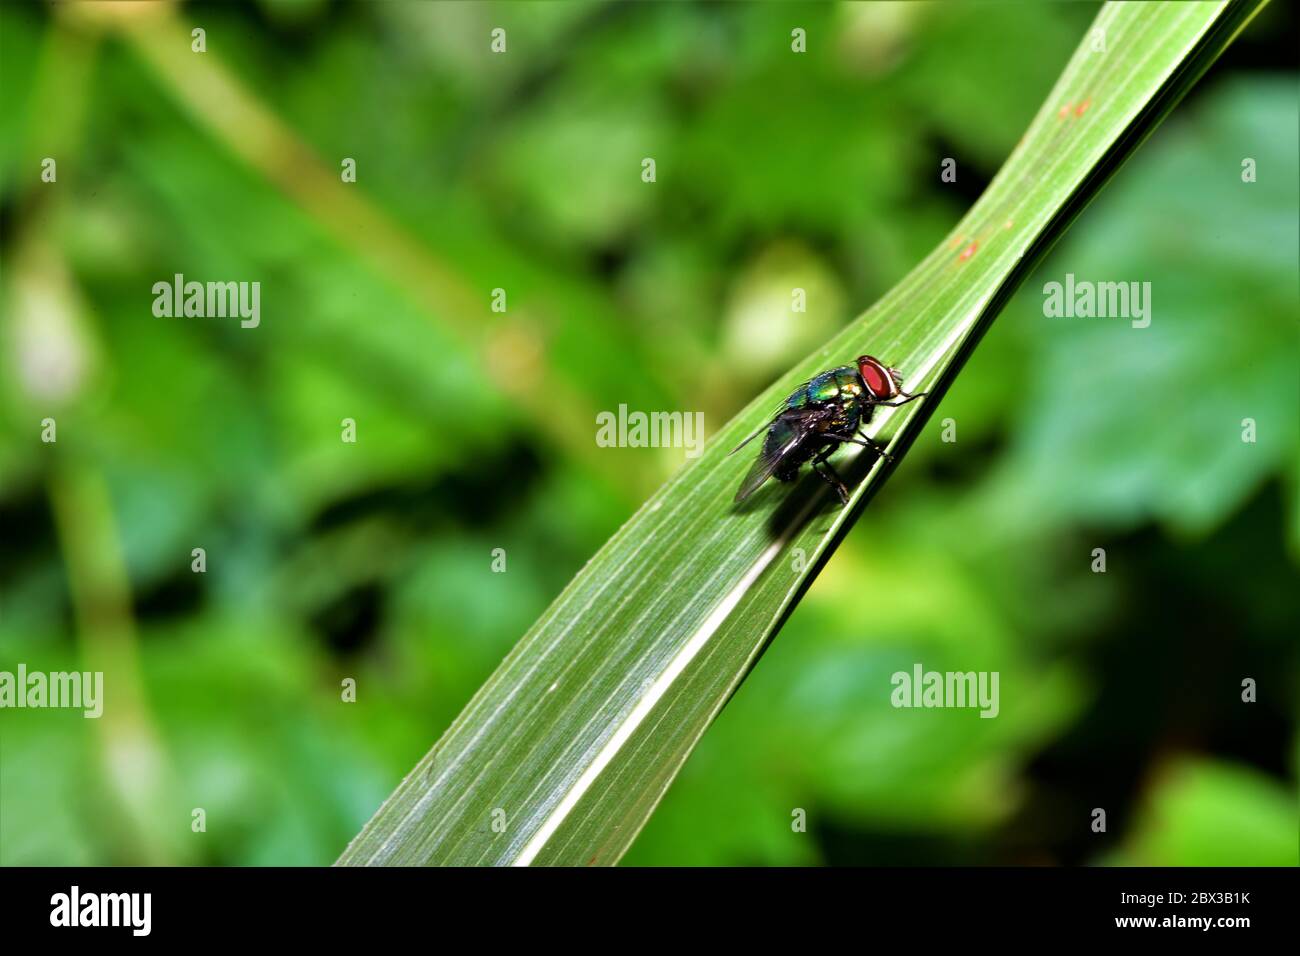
[339,0,1261,865]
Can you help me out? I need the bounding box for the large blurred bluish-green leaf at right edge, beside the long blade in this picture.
[1002,79,1300,545]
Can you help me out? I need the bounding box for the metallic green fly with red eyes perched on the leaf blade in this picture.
[733,355,924,503]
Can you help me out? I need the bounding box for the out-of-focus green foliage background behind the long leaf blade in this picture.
[0,1,1300,865]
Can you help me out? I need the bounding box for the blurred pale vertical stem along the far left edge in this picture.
[15,11,186,864]
